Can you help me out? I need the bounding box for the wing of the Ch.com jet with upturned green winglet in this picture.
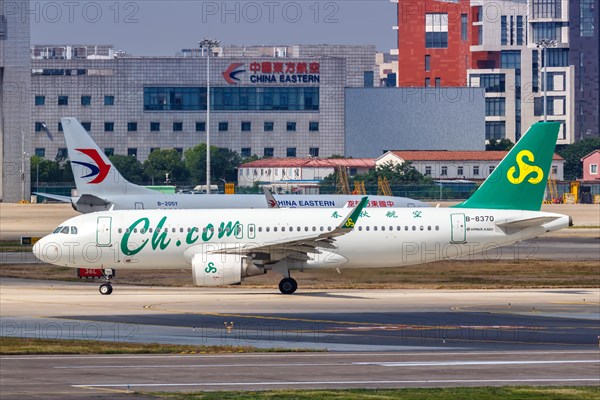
[211,197,369,262]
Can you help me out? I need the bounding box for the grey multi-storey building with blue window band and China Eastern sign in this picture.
[31,45,378,161]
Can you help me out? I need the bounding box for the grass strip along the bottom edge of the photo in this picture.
[152,386,600,400]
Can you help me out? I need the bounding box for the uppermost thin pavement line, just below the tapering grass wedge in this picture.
[0,349,600,360]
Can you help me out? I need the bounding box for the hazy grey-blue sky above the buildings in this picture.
[29,0,397,56]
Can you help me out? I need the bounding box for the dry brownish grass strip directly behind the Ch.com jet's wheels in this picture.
[0,260,600,290]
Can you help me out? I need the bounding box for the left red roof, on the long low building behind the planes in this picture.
[240,158,375,168]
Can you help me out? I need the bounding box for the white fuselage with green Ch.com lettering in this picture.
[34,208,569,269]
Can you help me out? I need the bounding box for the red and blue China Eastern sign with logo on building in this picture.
[223,61,321,85]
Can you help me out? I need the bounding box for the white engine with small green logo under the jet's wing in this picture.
[192,254,265,287]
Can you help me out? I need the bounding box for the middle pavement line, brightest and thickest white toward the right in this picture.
[53,359,600,369]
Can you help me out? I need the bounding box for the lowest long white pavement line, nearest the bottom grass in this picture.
[71,377,600,388]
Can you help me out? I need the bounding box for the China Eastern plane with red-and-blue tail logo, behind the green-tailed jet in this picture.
[34,118,429,213]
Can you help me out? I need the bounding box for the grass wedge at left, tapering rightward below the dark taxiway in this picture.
[0,337,314,355]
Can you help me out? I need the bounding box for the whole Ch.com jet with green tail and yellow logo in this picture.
[33,122,570,294]
